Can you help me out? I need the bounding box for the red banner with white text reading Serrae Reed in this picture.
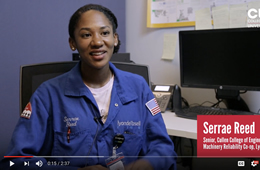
[197,115,260,158]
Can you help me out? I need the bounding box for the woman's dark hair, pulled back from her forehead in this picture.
[69,4,121,53]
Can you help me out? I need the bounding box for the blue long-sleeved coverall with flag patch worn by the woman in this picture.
[3,62,176,170]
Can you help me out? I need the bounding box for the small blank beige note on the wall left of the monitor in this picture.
[162,34,177,60]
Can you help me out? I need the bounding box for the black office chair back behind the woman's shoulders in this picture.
[20,61,150,112]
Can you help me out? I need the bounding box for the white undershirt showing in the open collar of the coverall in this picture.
[86,76,114,123]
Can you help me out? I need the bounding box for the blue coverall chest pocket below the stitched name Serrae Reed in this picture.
[53,129,92,156]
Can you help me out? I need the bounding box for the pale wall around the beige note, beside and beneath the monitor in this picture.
[126,0,260,112]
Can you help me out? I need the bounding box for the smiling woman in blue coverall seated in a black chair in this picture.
[3,4,176,170]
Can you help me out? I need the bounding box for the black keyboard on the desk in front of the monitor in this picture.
[175,106,256,119]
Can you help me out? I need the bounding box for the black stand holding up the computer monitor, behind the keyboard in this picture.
[216,89,250,112]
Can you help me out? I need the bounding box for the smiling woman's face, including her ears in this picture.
[69,10,118,69]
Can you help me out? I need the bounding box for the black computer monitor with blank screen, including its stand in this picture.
[179,28,260,111]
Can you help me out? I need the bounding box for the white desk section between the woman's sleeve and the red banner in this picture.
[162,111,197,139]
